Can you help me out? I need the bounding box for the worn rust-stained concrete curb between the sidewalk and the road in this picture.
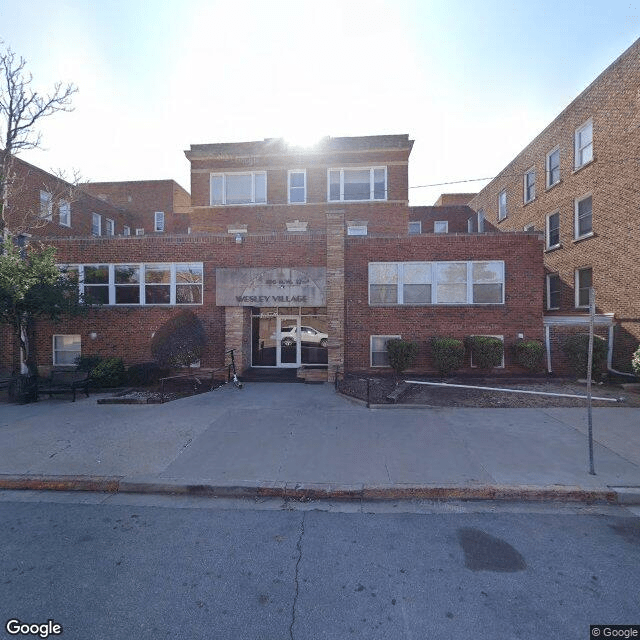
[0,475,640,505]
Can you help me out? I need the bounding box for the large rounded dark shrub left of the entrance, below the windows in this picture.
[151,309,207,367]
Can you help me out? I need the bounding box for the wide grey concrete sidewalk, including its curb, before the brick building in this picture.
[0,383,640,503]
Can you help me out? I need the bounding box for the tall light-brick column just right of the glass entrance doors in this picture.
[327,210,344,382]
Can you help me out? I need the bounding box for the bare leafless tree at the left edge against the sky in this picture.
[0,44,78,239]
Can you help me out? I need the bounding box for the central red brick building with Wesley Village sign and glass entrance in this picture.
[3,135,543,373]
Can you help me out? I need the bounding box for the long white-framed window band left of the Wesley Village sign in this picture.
[68,262,203,305]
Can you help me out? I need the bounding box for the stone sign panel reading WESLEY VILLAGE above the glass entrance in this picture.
[216,267,327,307]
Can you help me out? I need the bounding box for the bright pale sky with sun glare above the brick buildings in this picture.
[0,0,640,205]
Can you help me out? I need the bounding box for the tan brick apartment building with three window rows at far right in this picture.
[469,40,640,371]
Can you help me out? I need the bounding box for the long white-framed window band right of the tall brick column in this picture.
[369,260,505,305]
